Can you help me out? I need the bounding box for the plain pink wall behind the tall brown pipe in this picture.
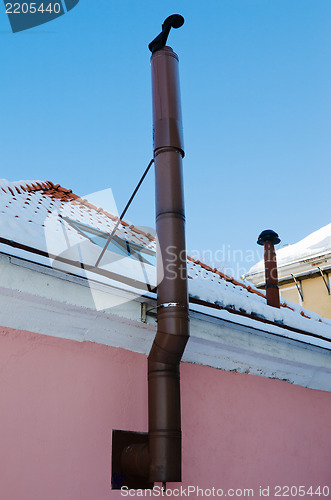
[0,328,331,500]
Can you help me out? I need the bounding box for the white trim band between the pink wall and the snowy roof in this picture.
[0,256,331,391]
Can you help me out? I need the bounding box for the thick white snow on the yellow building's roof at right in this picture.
[246,223,331,276]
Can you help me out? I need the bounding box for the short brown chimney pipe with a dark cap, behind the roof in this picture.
[257,229,280,308]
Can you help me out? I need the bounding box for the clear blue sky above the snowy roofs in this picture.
[0,0,331,274]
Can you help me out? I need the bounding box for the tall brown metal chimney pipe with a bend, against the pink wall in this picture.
[148,40,189,482]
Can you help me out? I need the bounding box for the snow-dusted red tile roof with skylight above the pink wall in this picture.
[0,180,331,348]
